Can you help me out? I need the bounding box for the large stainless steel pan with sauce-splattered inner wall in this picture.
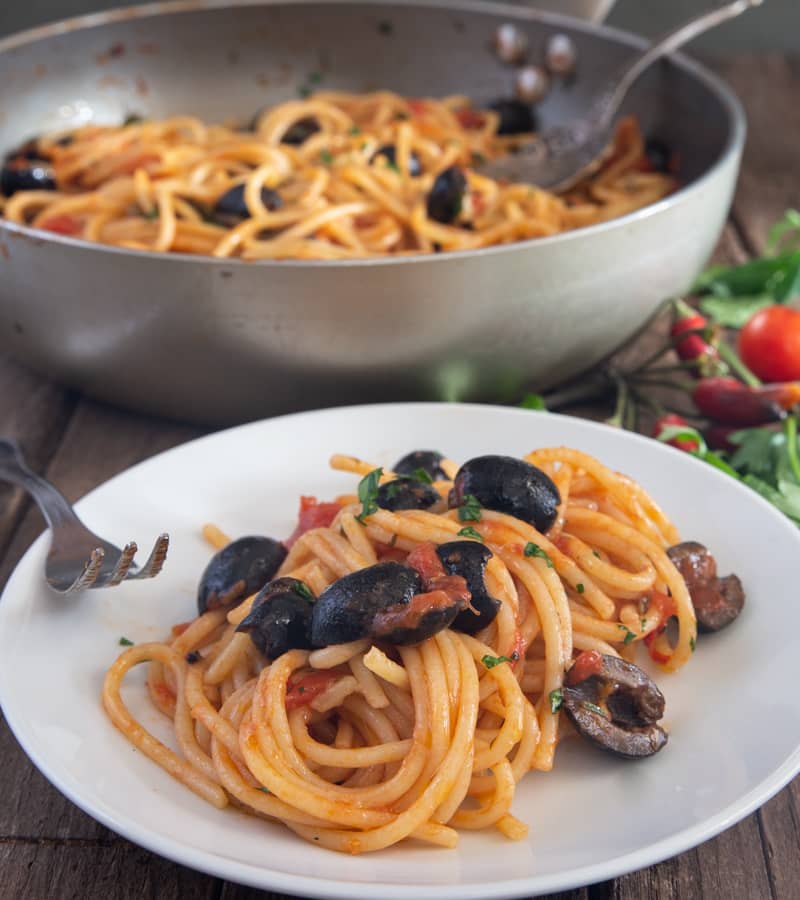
[0,0,744,423]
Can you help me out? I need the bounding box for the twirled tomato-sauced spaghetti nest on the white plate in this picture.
[103,447,696,853]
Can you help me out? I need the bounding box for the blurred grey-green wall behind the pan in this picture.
[0,0,800,53]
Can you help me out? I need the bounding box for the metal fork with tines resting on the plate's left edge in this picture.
[0,438,169,594]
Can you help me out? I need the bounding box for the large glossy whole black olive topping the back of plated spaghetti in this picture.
[450,456,561,532]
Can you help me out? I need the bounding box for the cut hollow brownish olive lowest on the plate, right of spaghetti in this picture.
[561,654,667,759]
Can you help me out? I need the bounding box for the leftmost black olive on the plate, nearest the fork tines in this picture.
[197,537,286,615]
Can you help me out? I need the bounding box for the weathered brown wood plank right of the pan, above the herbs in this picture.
[713,53,800,251]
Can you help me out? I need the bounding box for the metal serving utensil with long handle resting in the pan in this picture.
[481,0,763,192]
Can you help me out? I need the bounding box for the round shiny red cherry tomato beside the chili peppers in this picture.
[739,306,800,382]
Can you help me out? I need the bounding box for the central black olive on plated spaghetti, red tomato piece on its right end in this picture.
[311,562,465,647]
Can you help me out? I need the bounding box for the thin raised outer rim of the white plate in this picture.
[0,403,800,900]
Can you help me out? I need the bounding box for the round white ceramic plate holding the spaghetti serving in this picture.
[0,404,800,900]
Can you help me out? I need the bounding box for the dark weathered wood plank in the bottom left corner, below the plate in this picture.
[0,840,219,900]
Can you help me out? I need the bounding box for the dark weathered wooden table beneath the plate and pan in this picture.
[0,55,800,900]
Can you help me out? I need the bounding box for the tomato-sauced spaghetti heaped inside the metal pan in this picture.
[0,91,676,260]
